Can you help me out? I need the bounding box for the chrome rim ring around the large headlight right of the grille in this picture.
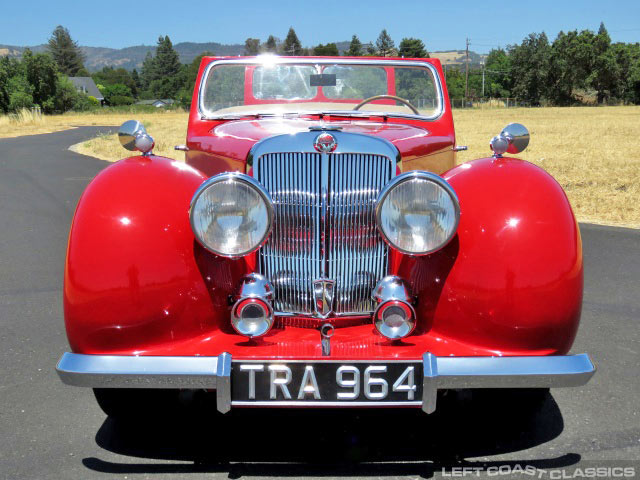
[376,170,460,257]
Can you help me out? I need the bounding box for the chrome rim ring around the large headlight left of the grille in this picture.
[189,172,274,258]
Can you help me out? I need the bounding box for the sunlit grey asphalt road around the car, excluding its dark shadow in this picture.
[0,127,640,479]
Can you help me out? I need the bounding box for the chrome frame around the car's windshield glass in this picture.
[198,56,447,121]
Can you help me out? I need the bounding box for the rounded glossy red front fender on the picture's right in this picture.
[399,158,583,354]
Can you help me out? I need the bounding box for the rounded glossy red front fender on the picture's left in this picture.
[64,156,252,353]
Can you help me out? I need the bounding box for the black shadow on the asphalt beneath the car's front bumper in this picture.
[83,394,581,478]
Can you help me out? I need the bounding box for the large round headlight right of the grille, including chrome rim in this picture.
[376,171,460,255]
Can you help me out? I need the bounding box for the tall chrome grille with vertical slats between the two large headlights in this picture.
[254,153,395,315]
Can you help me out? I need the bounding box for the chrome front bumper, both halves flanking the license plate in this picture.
[56,353,596,413]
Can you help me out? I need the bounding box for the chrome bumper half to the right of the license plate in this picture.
[422,353,596,413]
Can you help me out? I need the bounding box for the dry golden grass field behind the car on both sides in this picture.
[0,107,640,228]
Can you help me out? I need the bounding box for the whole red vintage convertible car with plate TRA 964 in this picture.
[57,56,595,414]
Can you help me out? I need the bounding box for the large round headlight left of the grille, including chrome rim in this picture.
[190,173,273,257]
